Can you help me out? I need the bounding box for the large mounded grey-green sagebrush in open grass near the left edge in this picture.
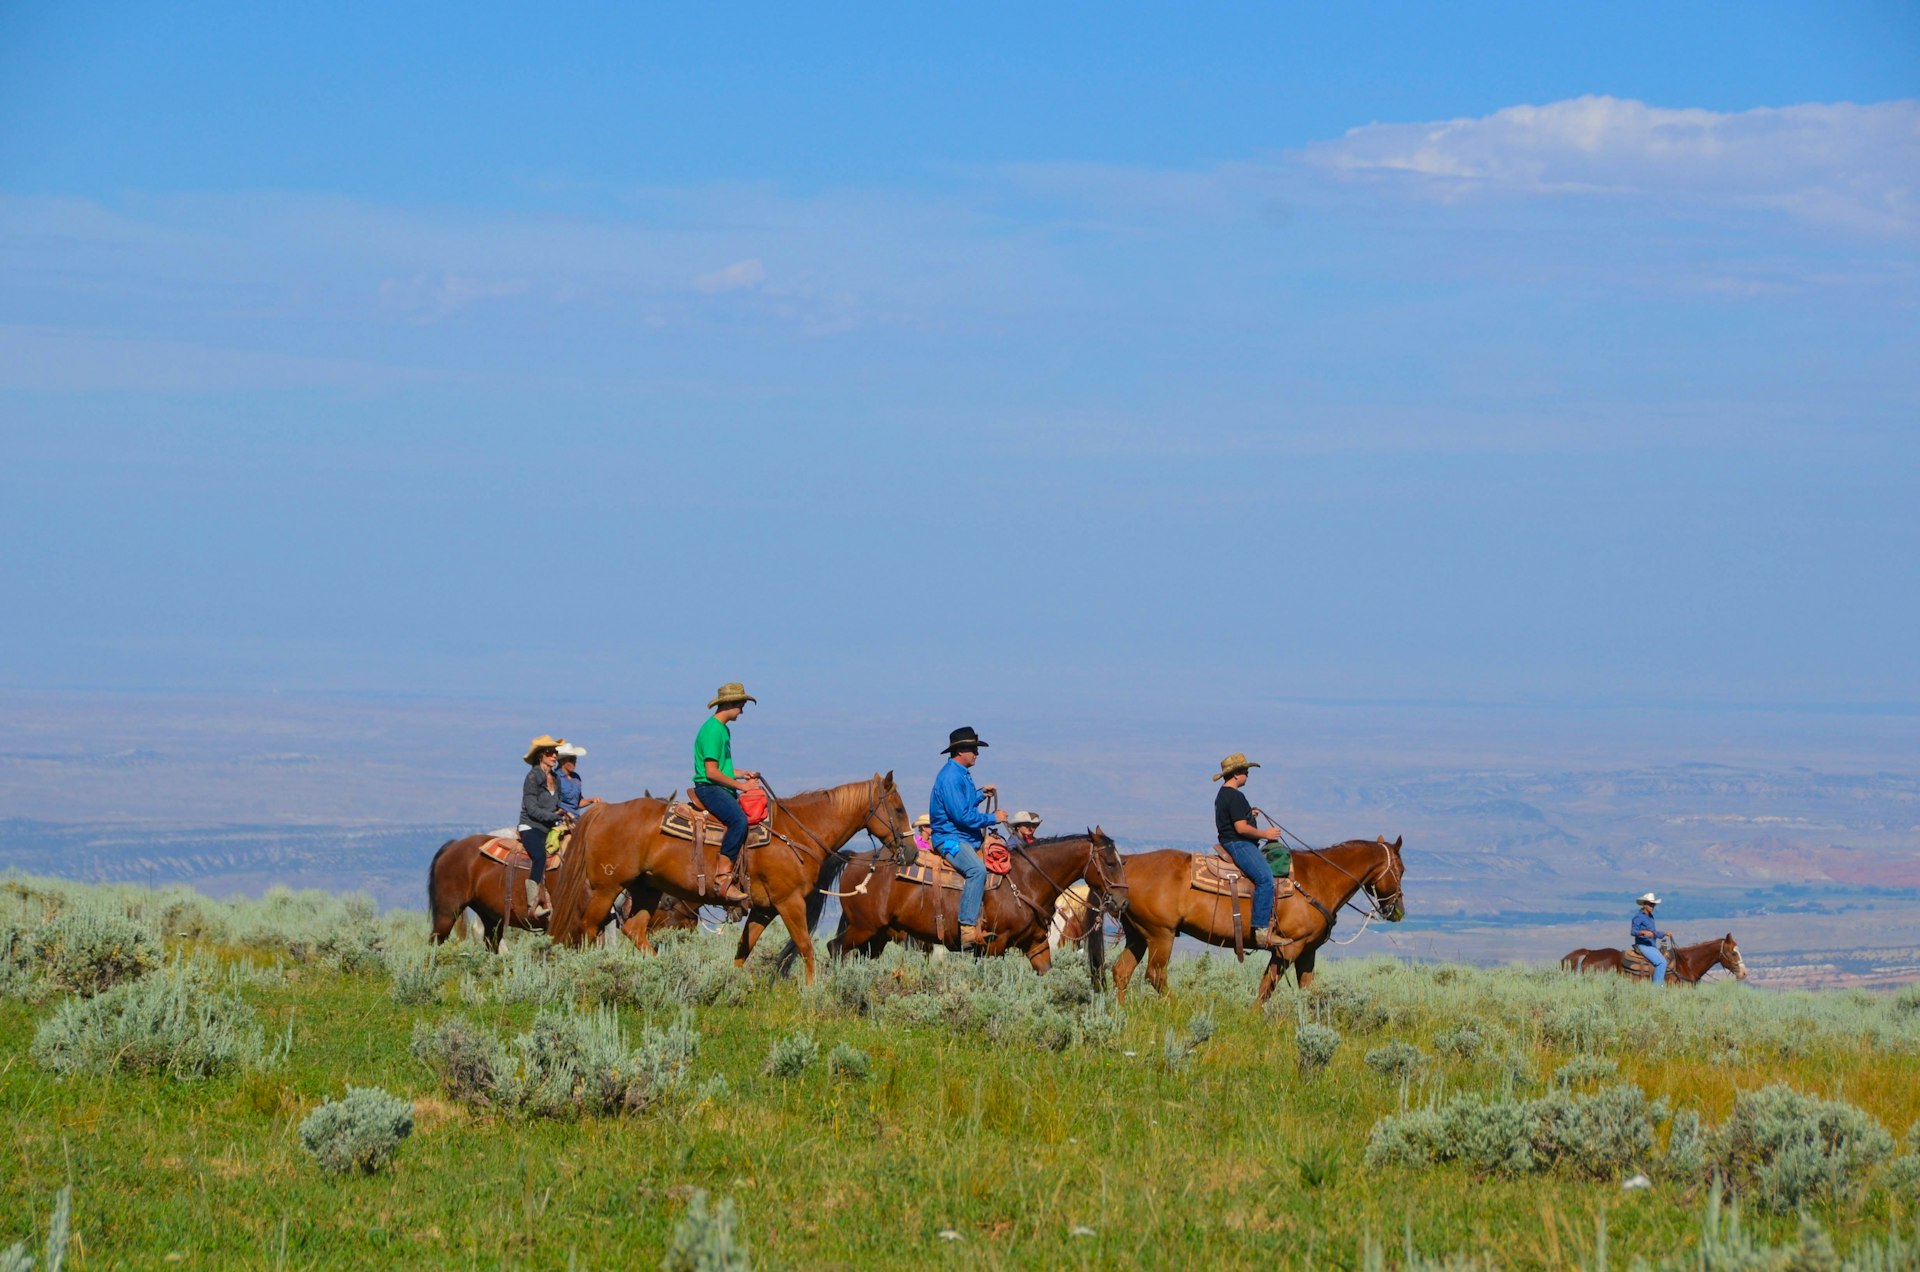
[33,965,280,1082]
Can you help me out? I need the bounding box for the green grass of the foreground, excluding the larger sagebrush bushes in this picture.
[0,880,1920,1268]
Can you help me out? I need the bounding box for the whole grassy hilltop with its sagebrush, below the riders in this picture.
[0,878,1920,1268]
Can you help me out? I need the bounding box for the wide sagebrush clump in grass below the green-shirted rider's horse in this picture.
[413,1005,699,1118]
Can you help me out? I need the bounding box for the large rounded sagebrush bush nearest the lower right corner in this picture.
[1715,1084,1893,1212]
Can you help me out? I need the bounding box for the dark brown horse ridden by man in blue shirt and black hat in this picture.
[828,826,1127,982]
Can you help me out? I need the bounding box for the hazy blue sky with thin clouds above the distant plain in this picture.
[0,4,1920,730]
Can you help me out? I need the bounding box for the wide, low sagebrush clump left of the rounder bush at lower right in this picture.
[1365,1086,1667,1178]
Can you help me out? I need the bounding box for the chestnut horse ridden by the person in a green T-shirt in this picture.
[551,772,912,982]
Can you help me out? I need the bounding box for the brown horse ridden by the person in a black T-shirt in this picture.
[1114,836,1407,1003]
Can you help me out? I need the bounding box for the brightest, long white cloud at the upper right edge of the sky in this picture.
[1300,96,1920,234]
